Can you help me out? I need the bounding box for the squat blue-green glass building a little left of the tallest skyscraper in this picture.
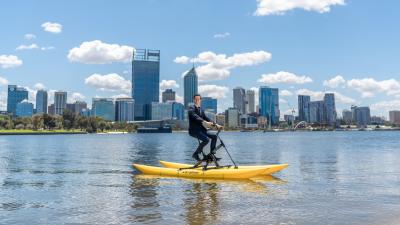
[92,98,115,121]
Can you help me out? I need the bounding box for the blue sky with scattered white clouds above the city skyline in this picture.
[0,0,400,118]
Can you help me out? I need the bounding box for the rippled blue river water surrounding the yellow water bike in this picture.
[0,132,400,224]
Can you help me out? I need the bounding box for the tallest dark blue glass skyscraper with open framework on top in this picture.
[132,49,160,120]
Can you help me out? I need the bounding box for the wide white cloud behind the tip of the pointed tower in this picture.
[174,51,272,81]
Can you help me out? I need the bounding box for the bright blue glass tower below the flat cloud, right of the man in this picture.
[259,86,280,125]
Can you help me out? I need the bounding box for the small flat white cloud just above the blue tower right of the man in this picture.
[257,71,313,84]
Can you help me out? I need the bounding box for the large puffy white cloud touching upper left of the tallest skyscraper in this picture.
[68,40,135,64]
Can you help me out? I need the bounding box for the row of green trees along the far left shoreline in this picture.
[0,110,137,133]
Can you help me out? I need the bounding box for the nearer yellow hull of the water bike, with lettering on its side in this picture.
[133,164,274,179]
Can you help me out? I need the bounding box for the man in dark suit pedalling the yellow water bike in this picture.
[188,94,218,161]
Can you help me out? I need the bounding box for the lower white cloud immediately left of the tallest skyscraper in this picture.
[85,73,132,93]
